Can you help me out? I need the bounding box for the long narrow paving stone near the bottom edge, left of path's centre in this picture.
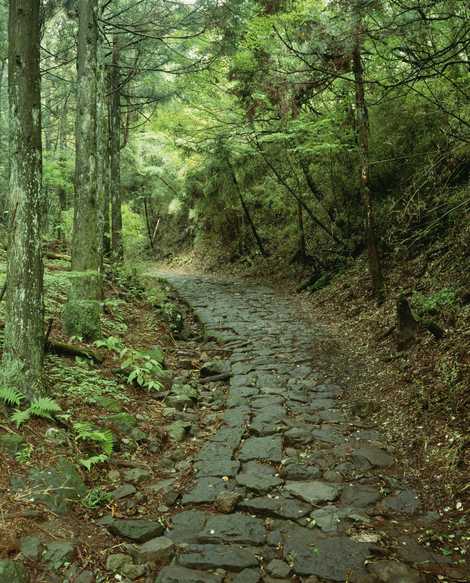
[178,544,258,581]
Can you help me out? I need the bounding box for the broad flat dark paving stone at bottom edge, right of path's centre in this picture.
[284,537,370,581]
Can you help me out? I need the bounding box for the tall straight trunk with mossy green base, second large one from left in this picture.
[63,0,102,340]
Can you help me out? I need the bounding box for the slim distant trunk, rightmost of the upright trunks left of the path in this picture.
[110,36,124,262]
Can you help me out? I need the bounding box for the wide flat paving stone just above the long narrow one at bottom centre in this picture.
[198,514,266,545]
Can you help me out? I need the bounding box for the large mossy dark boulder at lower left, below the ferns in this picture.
[11,458,87,514]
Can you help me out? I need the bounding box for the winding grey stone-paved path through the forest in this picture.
[156,275,454,583]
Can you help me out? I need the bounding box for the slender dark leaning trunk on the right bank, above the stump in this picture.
[353,15,384,303]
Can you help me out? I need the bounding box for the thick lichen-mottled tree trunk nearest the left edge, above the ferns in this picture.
[4,0,44,398]
